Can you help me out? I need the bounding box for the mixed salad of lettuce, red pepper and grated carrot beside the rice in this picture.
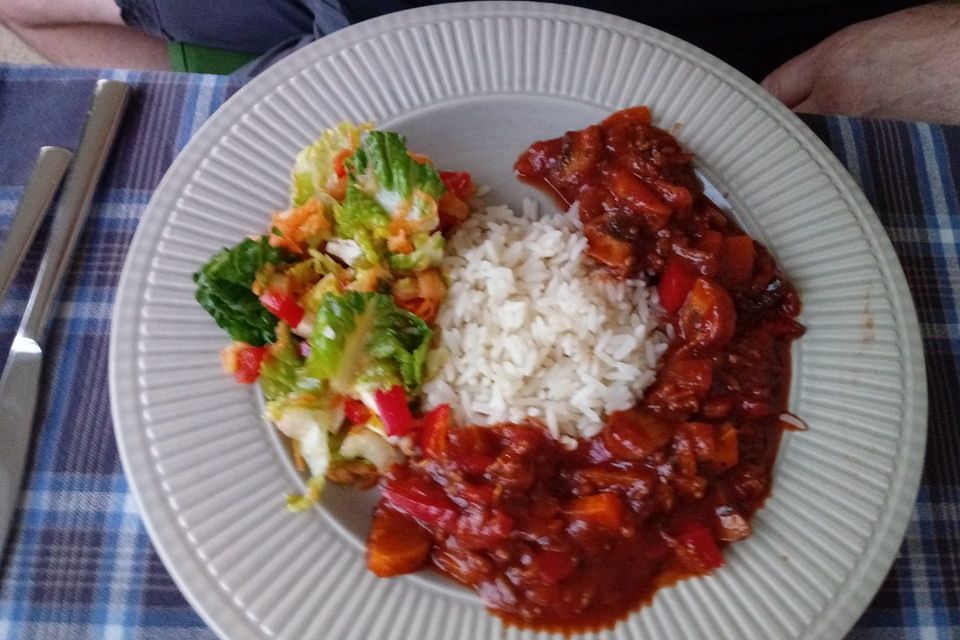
[193,122,474,510]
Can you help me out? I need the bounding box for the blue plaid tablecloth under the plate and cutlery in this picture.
[0,66,960,640]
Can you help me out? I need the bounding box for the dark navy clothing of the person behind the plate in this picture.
[117,0,922,81]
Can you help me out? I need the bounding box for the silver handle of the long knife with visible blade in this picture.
[18,80,131,343]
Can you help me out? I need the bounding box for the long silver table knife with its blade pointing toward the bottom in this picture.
[0,80,130,550]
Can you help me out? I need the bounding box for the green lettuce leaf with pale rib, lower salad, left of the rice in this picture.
[306,291,430,397]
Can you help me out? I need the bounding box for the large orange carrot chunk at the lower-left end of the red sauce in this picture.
[367,508,431,578]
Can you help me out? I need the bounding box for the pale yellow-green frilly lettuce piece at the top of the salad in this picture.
[290,121,372,206]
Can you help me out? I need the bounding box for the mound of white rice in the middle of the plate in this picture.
[424,199,667,438]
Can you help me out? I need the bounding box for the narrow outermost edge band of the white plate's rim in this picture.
[109,2,927,638]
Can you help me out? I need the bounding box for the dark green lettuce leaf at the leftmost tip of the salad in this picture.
[193,236,294,346]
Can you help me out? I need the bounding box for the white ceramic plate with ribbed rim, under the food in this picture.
[110,2,926,640]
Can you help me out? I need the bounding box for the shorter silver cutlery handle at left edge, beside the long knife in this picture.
[0,147,73,303]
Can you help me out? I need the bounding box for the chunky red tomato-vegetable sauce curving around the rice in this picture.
[368,107,803,631]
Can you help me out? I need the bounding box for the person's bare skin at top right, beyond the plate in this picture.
[761,2,960,124]
